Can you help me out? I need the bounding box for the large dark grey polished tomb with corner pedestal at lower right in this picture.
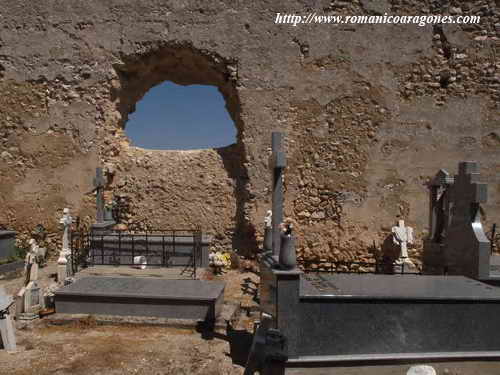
[260,255,500,364]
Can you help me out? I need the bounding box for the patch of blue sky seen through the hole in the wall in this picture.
[125,81,236,150]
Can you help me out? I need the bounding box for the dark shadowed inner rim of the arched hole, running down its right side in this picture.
[110,45,256,252]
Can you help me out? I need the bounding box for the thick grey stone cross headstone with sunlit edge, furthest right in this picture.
[444,162,490,279]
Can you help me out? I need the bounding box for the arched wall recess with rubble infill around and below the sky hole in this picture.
[107,44,256,253]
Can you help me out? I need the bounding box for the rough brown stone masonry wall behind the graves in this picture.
[0,0,500,260]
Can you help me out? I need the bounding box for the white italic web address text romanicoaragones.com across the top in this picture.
[274,12,481,26]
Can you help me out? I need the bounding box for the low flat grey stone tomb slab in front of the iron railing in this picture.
[55,277,225,322]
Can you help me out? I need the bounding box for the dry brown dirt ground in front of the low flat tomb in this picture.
[0,265,258,375]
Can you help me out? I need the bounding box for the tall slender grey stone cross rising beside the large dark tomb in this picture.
[269,132,286,255]
